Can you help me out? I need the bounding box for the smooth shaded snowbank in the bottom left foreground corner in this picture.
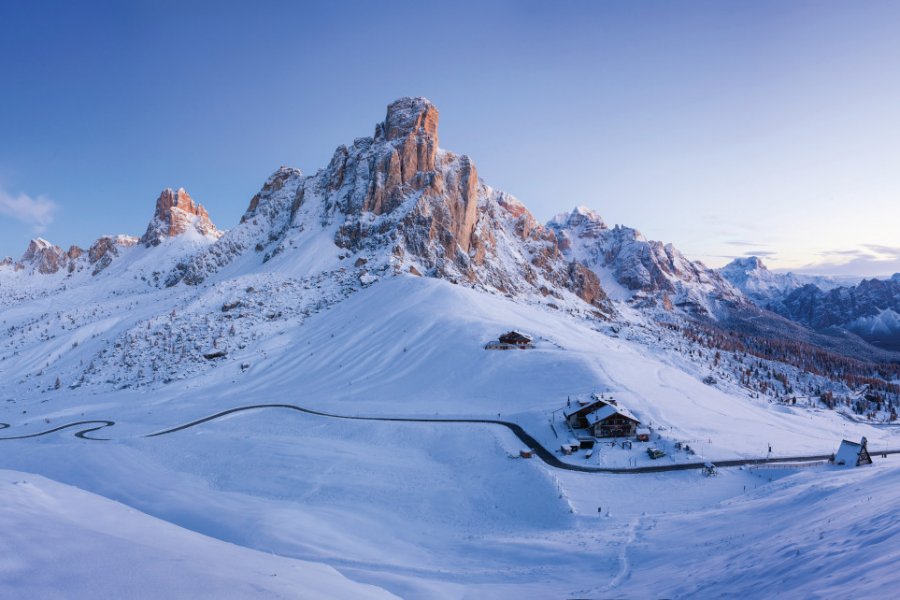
[0,470,395,599]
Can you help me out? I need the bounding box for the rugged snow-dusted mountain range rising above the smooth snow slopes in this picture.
[0,98,892,394]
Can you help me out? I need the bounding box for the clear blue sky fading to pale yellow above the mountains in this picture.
[0,0,900,276]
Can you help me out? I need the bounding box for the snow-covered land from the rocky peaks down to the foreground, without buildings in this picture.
[0,98,900,599]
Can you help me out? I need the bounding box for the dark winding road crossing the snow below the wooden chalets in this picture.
[0,404,900,475]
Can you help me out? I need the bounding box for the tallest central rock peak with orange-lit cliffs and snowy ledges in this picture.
[168,98,612,314]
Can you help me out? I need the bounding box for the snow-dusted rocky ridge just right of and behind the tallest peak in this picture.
[548,207,741,315]
